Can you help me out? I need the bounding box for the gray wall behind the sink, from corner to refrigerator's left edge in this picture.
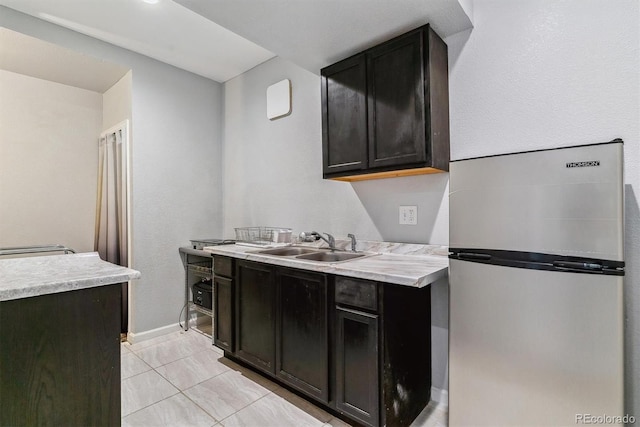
[222,58,449,398]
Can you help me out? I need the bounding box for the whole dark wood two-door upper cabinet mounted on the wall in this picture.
[321,25,449,181]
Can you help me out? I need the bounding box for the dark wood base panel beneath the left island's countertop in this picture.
[0,284,121,426]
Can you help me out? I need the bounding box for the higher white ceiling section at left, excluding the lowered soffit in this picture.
[0,0,275,82]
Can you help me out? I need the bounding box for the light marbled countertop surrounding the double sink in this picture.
[204,241,449,288]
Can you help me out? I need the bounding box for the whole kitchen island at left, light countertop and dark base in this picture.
[0,253,140,426]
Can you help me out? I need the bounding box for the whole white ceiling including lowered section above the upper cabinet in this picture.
[0,0,472,90]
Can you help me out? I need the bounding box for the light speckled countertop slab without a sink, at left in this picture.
[0,252,140,301]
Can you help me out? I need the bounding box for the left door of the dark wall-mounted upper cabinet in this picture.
[321,54,367,175]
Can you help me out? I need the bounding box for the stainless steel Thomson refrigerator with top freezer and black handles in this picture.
[449,139,624,426]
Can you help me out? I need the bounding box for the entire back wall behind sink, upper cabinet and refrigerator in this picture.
[223,0,640,415]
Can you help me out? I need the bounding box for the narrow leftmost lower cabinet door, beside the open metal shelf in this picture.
[213,276,235,353]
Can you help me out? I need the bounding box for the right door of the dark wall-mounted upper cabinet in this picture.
[367,31,427,168]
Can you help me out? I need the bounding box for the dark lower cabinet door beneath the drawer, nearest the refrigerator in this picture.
[335,307,380,426]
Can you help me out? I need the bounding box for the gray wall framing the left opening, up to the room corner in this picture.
[0,6,222,336]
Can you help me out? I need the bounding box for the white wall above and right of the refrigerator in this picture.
[446,0,640,417]
